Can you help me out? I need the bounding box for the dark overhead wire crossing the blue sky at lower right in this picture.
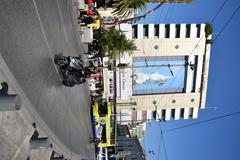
[162,111,240,134]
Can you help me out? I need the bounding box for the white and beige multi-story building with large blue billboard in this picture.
[116,24,211,124]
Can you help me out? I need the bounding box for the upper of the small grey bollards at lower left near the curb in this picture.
[30,137,52,149]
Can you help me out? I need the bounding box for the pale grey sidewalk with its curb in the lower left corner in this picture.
[0,53,79,160]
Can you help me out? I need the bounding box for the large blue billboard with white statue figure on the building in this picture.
[132,56,186,95]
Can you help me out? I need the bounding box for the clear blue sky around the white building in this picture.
[138,0,240,160]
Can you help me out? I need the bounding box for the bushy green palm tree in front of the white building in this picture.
[99,28,136,59]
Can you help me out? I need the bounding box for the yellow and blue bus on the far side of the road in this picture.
[93,102,115,148]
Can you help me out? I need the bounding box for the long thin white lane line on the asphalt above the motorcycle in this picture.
[33,0,59,74]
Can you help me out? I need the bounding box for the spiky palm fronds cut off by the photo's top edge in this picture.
[113,0,147,17]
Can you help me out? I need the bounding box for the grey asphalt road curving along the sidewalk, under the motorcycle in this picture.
[0,0,95,160]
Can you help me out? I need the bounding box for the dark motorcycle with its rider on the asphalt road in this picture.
[54,55,91,87]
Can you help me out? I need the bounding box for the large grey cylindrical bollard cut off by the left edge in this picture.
[0,95,21,111]
